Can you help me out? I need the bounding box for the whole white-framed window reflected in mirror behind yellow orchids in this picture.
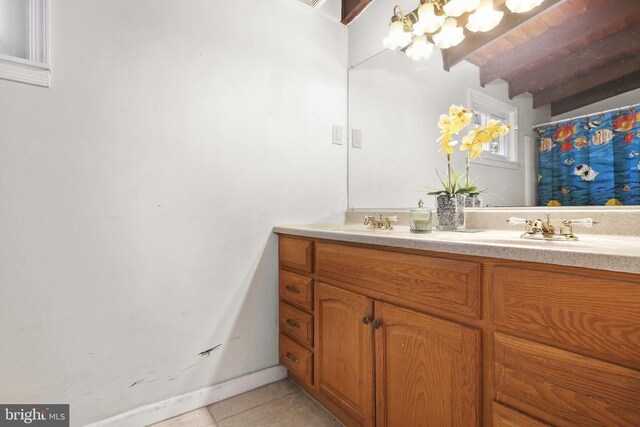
[469,89,518,169]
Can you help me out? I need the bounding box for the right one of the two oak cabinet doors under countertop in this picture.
[375,301,480,427]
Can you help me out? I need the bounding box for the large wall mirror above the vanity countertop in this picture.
[349,0,640,208]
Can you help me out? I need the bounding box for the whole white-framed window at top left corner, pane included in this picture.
[0,0,51,87]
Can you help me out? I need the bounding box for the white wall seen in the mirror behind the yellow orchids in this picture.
[349,0,549,208]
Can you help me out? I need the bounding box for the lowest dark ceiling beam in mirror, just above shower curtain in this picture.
[551,71,640,116]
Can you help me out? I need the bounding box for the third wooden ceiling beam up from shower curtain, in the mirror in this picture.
[505,24,640,98]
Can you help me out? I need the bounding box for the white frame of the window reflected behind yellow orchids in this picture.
[469,89,518,169]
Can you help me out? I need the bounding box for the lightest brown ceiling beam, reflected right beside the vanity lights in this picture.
[442,0,567,71]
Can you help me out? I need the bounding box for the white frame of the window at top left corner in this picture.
[0,0,51,87]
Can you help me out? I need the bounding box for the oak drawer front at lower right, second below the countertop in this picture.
[494,333,640,427]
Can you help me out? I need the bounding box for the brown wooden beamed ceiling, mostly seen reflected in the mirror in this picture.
[342,0,640,116]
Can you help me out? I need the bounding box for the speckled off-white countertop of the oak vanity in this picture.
[273,223,640,274]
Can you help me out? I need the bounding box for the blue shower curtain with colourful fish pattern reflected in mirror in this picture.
[534,105,640,206]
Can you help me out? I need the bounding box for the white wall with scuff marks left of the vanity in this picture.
[0,0,347,425]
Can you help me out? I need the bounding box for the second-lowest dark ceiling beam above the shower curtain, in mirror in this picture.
[533,53,640,108]
